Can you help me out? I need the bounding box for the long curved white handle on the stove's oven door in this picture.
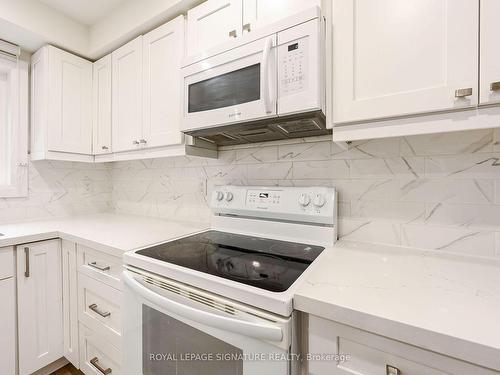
[123,271,283,342]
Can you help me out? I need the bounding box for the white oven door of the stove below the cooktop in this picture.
[123,270,291,375]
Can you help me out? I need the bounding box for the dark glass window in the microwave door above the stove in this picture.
[188,64,260,113]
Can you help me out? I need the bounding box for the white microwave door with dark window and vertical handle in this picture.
[182,34,277,131]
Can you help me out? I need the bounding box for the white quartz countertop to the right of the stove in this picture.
[294,242,500,370]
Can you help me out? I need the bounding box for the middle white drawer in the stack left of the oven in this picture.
[78,274,122,346]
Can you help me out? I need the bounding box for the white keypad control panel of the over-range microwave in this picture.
[279,37,308,96]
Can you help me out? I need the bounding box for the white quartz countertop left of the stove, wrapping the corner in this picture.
[0,214,209,256]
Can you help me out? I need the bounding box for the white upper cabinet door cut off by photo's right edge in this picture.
[479,0,500,104]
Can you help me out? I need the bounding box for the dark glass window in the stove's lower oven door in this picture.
[142,305,243,375]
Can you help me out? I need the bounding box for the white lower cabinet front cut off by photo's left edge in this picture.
[0,247,16,375]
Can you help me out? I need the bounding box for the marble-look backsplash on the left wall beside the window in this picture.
[0,161,112,223]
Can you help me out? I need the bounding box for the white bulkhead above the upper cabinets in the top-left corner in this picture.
[0,0,202,60]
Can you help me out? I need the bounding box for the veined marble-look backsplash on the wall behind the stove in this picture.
[111,130,500,256]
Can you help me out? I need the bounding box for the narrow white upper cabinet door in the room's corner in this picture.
[92,55,111,155]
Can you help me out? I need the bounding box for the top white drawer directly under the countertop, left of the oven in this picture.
[77,245,122,290]
